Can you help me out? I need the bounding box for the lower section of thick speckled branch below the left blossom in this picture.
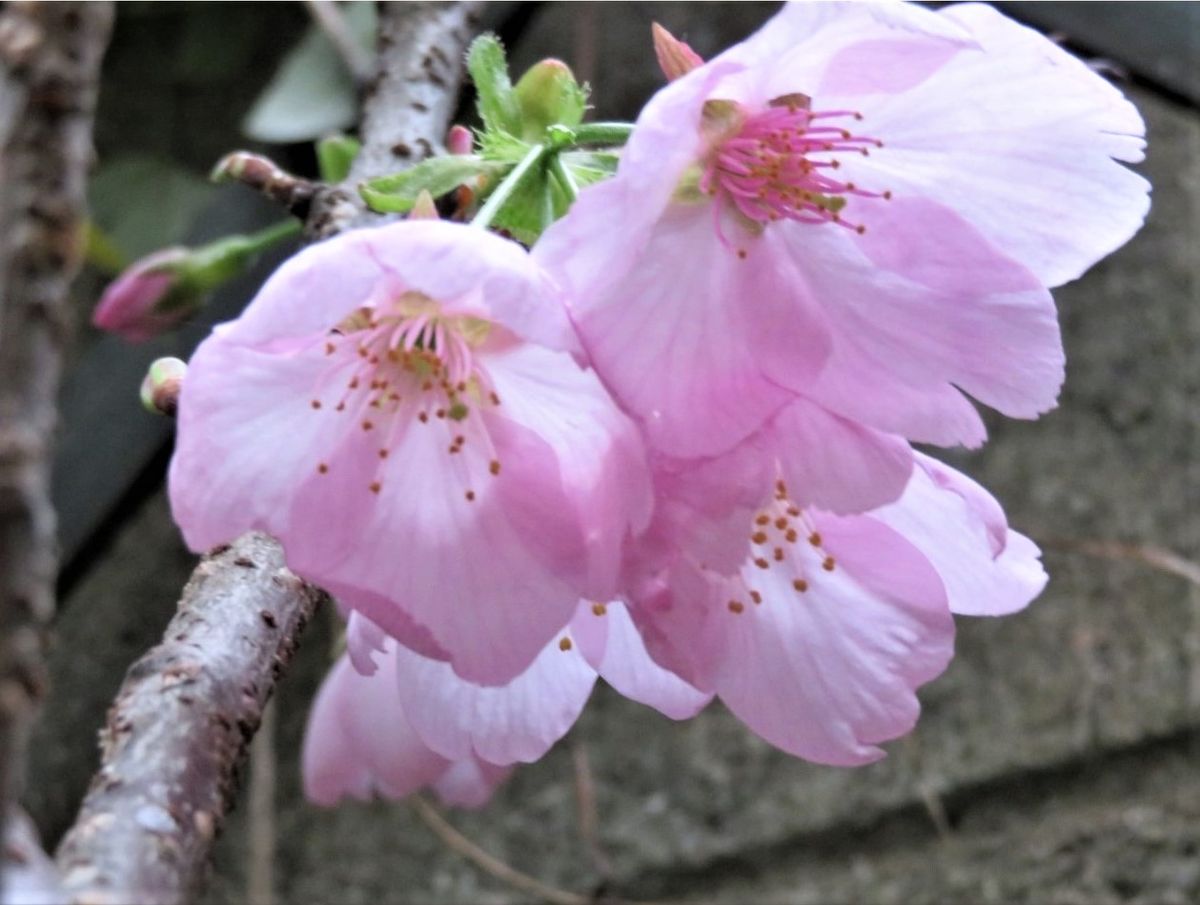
[58,534,323,903]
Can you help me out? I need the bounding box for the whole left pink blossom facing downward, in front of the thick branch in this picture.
[170,221,650,684]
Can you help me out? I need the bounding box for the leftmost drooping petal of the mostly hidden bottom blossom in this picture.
[301,655,449,805]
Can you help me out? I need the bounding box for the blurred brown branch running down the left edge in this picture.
[0,2,112,888]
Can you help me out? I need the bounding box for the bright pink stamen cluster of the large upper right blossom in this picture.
[698,95,892,248]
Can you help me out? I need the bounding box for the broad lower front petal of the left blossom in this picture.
[282,396,586,684]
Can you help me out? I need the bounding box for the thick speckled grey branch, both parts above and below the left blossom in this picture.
[51,4,476,905]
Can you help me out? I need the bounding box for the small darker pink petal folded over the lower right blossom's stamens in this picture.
[768,397,912,513]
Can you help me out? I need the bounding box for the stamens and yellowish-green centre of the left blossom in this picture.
[310,292,500,502]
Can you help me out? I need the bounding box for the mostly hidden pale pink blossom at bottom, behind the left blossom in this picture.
[304,603,710,805]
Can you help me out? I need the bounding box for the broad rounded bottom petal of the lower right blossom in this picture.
[718,516,954,766]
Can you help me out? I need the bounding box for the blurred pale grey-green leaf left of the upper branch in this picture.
[242,4,378,144]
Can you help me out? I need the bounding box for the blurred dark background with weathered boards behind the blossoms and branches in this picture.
[25,2,1200,903]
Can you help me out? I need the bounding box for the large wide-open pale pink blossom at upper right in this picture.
[534,4,1147,457]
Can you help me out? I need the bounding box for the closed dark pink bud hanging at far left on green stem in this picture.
[91,248,193,342]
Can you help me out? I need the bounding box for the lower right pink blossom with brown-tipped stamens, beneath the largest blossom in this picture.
[631,443,1045,766]
